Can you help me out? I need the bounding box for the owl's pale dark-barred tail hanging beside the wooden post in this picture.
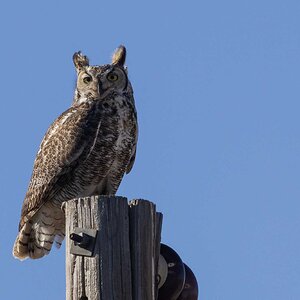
[13,206,65,260]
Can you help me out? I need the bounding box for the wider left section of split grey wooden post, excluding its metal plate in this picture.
[65,196,132,300]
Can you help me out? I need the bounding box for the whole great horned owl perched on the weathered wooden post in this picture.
[13,46,137,259]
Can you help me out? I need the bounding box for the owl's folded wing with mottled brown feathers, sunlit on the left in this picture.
[19,107,95,228]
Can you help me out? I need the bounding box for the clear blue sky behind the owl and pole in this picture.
[0,0,300,300]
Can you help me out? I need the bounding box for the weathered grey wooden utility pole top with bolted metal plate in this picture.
[64,196,162,300]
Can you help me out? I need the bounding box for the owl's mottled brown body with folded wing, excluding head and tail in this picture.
[19,94,137,229]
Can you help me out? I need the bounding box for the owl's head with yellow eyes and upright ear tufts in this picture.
[73,46,131,104]
